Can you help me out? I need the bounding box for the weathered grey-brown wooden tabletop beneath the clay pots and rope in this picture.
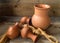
[0,16,60,43]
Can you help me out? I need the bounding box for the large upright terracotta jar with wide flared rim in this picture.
[32,4,50,29]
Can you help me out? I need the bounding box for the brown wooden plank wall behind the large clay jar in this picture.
[0,0,60,16]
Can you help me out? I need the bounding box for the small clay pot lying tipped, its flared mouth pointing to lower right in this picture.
[21,25,37,42]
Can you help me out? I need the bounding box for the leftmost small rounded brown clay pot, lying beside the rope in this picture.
[7,23,19,39]
